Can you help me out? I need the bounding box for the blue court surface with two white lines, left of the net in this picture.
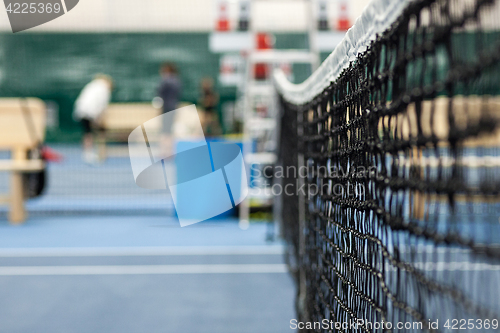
[0,216,295,333]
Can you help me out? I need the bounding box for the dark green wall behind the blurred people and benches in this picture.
[0,32,307,141]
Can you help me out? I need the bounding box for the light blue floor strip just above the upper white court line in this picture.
[0,216,280,250]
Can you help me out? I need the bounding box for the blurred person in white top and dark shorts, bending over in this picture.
[73,74,113,164]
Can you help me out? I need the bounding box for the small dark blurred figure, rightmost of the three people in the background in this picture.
[199,77,222,136]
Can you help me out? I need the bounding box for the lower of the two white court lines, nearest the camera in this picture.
[0,264,288,276]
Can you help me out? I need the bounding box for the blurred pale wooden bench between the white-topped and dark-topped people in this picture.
[97,103,161,161]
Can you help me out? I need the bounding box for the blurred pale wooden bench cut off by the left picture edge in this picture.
[0,98,46,224]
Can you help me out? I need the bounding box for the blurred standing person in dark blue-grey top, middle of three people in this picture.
[158,63,182,155]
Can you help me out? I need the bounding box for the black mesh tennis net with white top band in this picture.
[275,0,500,332]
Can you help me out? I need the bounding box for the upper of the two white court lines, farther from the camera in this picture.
[0,245,284,258]
